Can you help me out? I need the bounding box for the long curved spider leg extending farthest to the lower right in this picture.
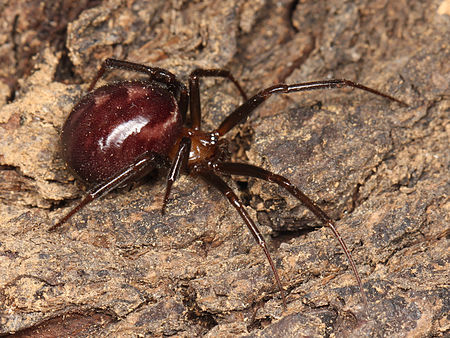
[215,162,367,306]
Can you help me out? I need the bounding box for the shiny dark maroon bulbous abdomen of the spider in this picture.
[61,81,183,183]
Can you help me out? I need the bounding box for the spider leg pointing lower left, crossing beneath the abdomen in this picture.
[48,154,156,231]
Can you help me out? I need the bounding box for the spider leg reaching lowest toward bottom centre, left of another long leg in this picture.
[195,169,287,309]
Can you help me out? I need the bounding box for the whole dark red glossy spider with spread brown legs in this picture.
[49,58,406,308]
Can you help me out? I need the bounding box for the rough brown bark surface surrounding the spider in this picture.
[0,0,450,337]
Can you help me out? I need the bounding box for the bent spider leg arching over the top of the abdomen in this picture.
[88,58,188,121]
